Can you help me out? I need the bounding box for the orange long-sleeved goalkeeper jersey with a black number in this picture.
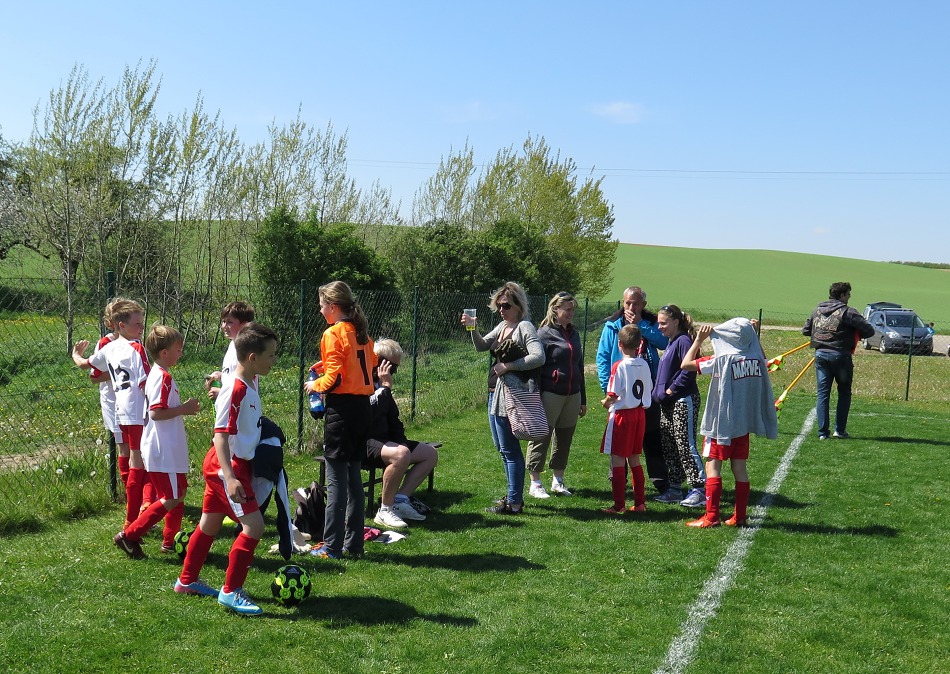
[314,320,377,396]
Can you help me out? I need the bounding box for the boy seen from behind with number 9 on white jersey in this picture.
[600,324,653,515]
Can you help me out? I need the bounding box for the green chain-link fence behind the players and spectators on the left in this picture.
[0,279,618,531]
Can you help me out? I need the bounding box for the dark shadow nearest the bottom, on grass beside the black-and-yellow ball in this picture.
[294,595,478,629]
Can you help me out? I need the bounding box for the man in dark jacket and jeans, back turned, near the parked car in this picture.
[802,282,874,440]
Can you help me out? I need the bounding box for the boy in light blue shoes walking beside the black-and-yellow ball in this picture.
[175,322,277,615]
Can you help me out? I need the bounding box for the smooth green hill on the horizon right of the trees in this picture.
[610,243,950,324]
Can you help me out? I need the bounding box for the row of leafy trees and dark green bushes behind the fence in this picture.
[0,61,617,336]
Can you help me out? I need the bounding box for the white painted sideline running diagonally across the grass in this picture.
[653,408,816,674]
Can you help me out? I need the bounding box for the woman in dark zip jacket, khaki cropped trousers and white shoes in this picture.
[528,292,587,498]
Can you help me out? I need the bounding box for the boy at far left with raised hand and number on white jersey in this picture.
[73,299,150,526]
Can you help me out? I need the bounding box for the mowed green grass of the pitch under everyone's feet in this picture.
[0,332,950,674]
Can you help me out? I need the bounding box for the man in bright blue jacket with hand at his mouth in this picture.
[597,286,670,494]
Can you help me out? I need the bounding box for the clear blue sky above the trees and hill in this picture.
[0,0,950,262]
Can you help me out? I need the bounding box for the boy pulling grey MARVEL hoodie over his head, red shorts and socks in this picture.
[681,318,778,529]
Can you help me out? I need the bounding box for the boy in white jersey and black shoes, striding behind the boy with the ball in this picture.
[115,325,201,559]
